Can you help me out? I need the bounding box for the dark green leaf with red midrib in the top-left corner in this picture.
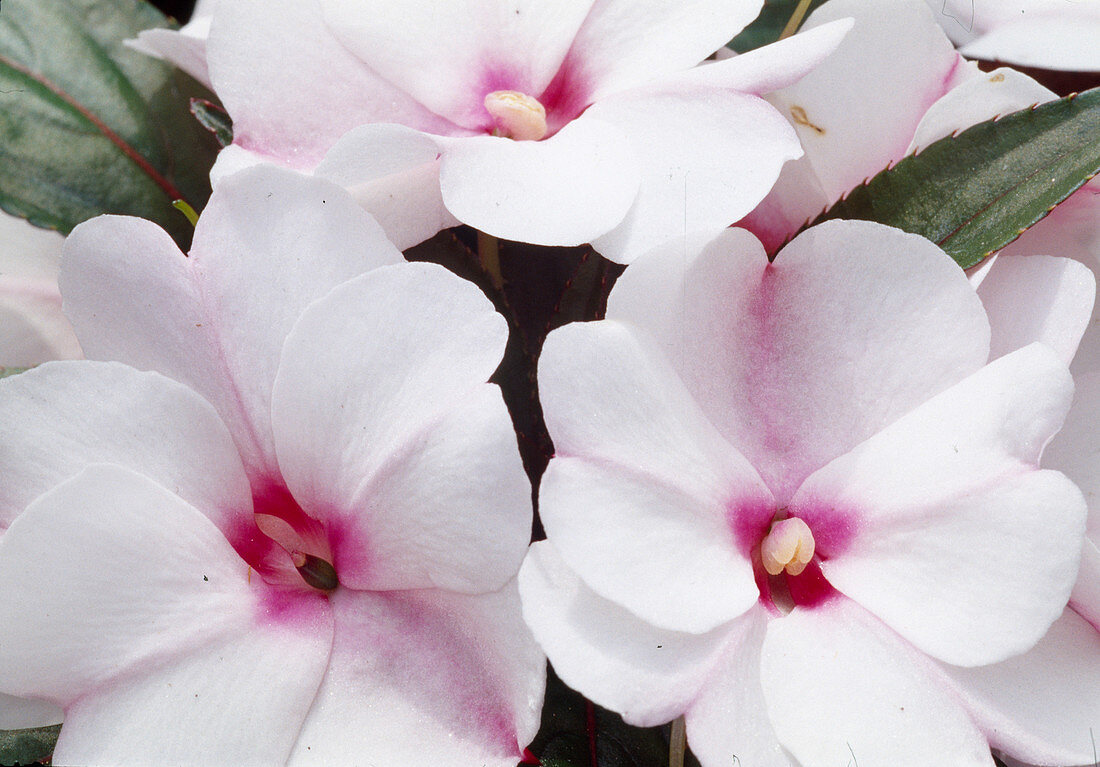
[0,0,218,245]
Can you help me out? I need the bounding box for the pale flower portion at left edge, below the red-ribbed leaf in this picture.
[0,213,80,368]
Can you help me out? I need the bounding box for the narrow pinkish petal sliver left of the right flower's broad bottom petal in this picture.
[684,606,793,767]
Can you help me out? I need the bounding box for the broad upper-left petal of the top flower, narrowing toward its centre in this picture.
[207,0,461,169]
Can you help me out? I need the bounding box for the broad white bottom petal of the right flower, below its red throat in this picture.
[760,598,993,767]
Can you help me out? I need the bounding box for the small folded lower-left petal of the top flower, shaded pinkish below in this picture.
[314,124,459,250]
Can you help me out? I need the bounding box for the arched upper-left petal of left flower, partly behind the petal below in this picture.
[0,362,252,533]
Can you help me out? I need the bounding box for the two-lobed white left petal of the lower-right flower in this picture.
[539,321,776,634]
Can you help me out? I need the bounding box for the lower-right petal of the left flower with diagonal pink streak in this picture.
[289,582,546,767]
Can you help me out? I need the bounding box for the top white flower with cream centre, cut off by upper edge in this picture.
[139,0,848,262]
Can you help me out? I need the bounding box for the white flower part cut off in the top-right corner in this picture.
[925,0,1100,72]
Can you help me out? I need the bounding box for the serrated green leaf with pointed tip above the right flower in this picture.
[813,88,1100,269]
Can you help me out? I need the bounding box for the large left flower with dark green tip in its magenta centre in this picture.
[0,168,545,767]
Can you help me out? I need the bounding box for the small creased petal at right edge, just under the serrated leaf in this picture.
[978,255,1097,365]
